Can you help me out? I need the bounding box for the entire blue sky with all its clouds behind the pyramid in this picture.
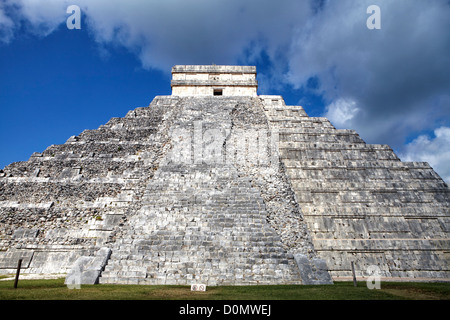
[0,0,450,182]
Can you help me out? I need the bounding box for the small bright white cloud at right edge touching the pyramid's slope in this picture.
[399,127,450,183]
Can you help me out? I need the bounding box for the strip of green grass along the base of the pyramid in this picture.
[0,279,450,300]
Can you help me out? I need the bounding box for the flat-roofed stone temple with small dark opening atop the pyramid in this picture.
[171,65,258,97]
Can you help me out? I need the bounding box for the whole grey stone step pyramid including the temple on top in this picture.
[0,65,450,285]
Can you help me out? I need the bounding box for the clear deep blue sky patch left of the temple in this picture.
[0,26,170,167]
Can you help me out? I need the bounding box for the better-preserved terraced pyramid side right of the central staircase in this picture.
[260,96,450,280]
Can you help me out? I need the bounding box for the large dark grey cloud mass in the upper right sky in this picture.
[287,0,450,148]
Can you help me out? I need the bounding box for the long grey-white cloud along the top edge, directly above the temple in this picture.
[0,0,311,72]
